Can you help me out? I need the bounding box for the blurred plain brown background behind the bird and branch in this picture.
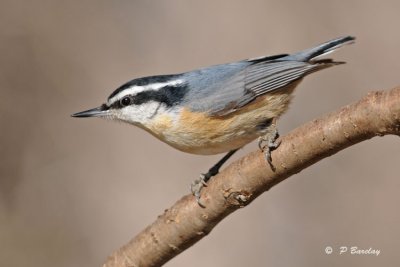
[0,0,400,267]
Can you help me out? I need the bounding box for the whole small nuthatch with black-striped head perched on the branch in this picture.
[71,36,355,206]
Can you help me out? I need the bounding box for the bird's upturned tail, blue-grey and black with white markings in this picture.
[286,36,356,62]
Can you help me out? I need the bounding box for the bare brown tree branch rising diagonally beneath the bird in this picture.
[103,87,400,267]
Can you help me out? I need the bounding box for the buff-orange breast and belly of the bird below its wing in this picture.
[145,89,290,155]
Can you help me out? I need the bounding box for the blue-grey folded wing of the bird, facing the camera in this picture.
[185,60,332,116]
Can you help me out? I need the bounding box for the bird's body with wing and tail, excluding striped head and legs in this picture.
[148,37,353,154]
